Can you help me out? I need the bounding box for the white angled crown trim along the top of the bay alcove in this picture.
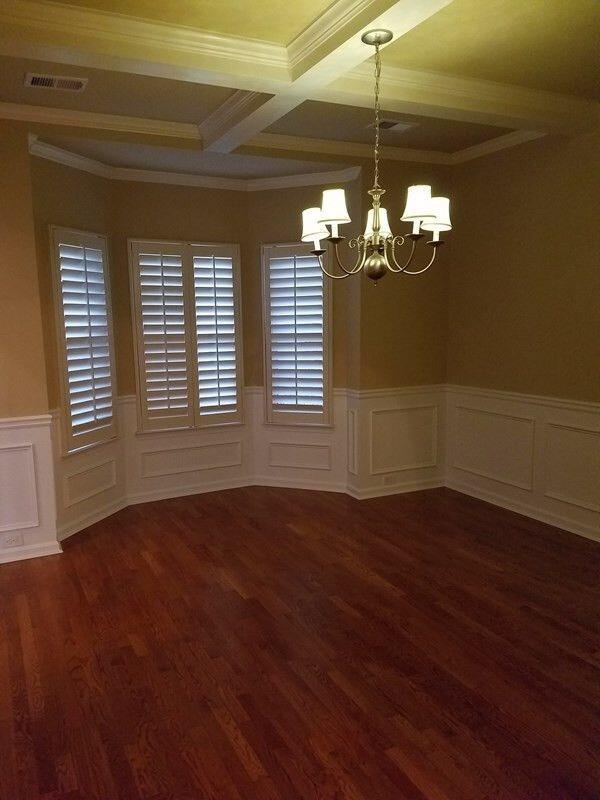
[29,134,360,192]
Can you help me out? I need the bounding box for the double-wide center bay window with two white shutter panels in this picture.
[129,241,242,430]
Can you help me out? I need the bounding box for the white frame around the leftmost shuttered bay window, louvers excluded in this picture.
[49,225,117,456]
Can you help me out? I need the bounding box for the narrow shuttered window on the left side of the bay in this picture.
[51,227,116,451]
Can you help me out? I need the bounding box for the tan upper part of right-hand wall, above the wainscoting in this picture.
[447,133,600,400]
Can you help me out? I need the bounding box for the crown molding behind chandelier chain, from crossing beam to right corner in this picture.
[246,133,451,164]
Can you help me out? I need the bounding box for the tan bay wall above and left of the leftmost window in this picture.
[31,158,115,408]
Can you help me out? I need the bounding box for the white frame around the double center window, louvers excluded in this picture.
[127,238,244,434]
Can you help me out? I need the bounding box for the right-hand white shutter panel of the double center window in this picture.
[192,245,240,419]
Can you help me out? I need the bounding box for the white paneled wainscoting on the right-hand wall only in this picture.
[446,386,600,540]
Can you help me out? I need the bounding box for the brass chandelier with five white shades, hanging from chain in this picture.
[302,30,452,282]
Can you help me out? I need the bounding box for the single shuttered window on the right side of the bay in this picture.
[263,245,331,424]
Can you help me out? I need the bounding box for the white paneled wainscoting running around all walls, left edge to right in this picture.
[0,385,600,563]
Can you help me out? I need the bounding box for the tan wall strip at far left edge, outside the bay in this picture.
[0,121,48,417]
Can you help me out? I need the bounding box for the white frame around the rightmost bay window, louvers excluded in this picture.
[261,242,333,428]
